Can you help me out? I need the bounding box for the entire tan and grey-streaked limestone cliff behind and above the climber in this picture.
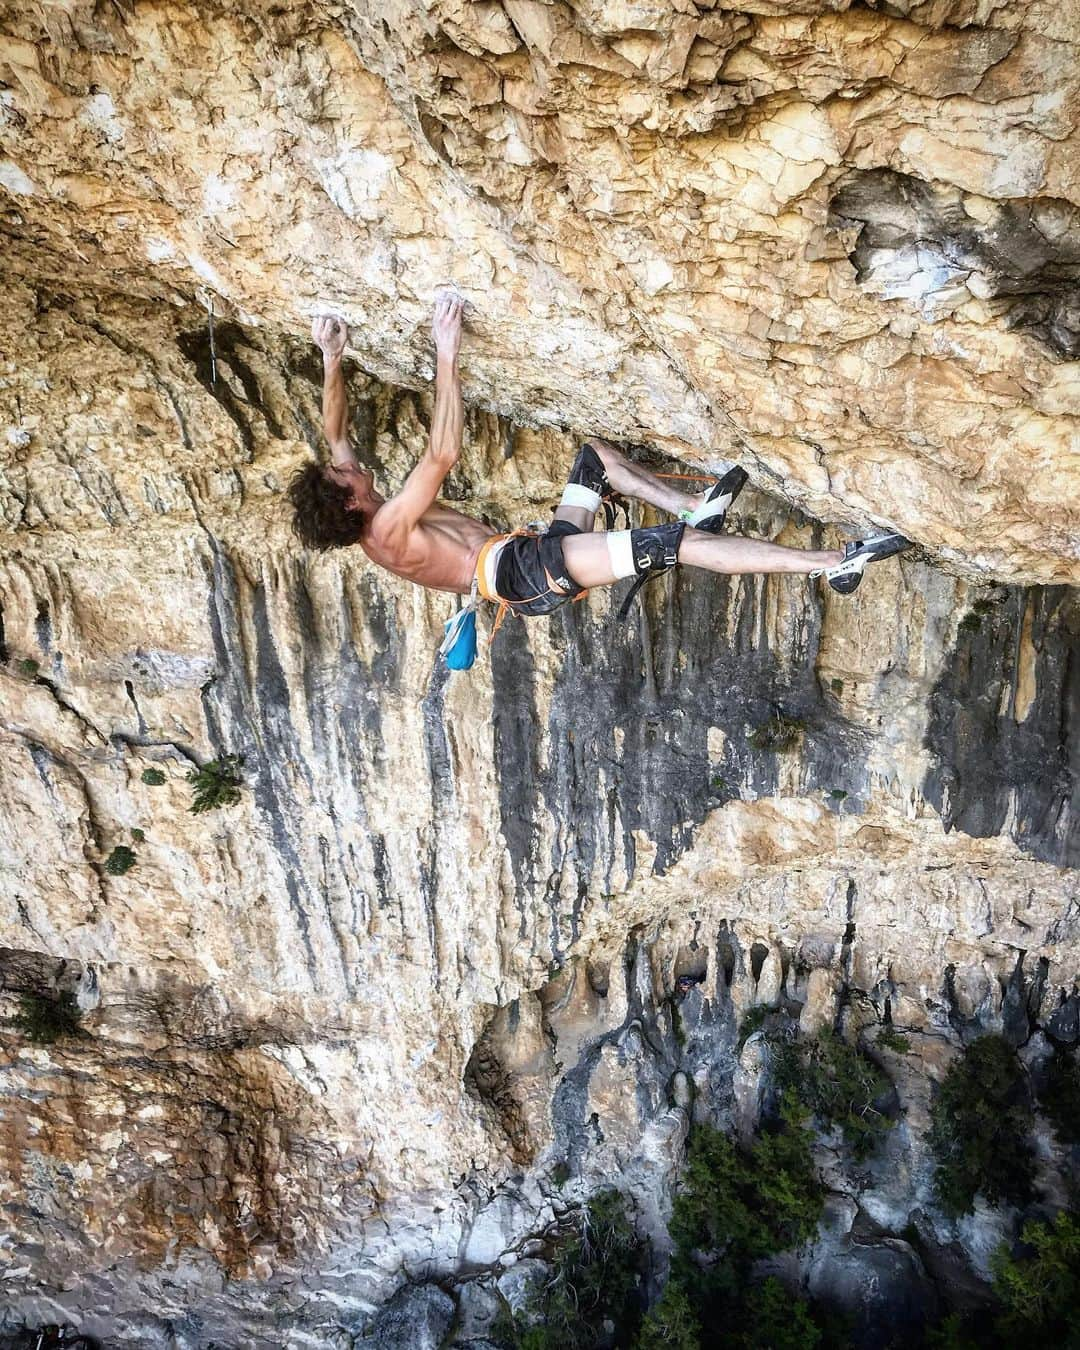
[0,0,1080,1350]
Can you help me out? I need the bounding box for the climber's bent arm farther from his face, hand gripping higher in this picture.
[379,293,464,533]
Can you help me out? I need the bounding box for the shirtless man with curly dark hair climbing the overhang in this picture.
[289,294,909,629]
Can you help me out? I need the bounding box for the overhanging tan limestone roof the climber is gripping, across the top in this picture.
[0,0,1080,582]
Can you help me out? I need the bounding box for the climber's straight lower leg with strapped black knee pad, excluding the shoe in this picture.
[563,524,844,587]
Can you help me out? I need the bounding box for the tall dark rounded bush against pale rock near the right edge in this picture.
[930,1035,1034,1215]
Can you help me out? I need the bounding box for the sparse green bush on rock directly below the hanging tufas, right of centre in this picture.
[772,1031,895,1158]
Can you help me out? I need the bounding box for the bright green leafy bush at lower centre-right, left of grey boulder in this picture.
[668,1099,822,1264]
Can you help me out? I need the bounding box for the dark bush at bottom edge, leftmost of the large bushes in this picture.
[498,1191,645,1350]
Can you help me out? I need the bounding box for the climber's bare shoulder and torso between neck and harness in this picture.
[360,497,495,595]
